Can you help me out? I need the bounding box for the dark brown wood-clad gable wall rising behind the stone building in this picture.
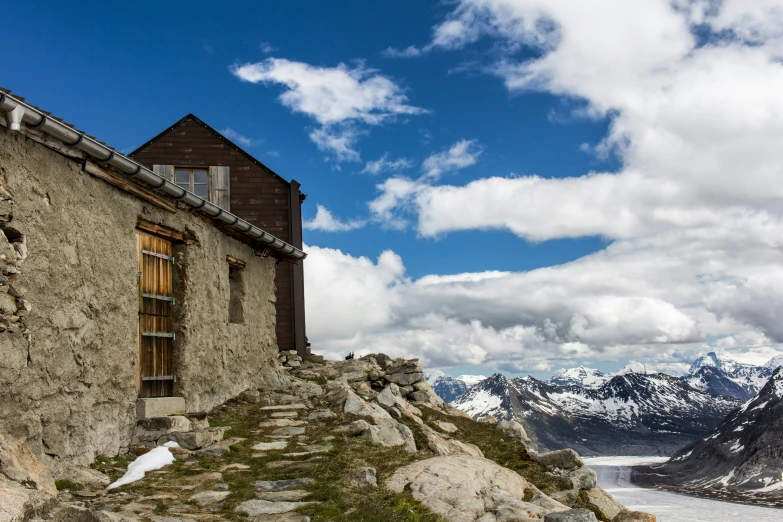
[130,114,306,355]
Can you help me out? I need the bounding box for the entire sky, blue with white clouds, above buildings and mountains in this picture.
[9,0,783,376]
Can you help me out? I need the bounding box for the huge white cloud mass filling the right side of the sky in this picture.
[308,0,783,371]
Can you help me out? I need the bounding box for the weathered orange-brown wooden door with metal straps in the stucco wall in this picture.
[136,231,174,397]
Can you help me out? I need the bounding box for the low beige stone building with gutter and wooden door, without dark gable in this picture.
[0,91,305,464]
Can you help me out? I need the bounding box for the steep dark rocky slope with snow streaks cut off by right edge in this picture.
[655,367,783,500]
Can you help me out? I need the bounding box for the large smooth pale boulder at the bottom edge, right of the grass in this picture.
[386,455,568,522]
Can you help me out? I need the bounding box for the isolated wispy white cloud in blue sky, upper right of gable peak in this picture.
[231,58,426,161]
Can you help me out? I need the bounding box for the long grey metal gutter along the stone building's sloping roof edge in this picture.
[0,93,307,259]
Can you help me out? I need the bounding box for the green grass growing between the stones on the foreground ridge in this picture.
[92,381,607,522]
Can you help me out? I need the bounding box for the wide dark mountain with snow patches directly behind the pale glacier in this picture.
[452,372,740,455]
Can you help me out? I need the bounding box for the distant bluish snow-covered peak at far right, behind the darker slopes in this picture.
[682,352,775,401]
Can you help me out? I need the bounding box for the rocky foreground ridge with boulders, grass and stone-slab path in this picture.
[0,354,654,522]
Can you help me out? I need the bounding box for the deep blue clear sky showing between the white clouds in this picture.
[5,1,613,277]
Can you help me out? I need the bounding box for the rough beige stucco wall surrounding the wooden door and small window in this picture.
[0,129,280,464]
